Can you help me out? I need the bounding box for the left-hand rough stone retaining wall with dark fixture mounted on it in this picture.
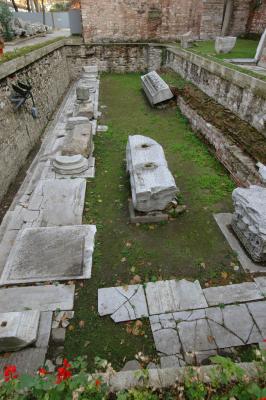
[0,42,70,200]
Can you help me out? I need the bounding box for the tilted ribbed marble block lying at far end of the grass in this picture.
[141,71,174,105]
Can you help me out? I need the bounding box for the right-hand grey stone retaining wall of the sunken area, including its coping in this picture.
[165,47,266,136]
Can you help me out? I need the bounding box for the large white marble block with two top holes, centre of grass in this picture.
[126,135,178,212]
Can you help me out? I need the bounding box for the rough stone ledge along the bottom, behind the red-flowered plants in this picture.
[93,362,262,392]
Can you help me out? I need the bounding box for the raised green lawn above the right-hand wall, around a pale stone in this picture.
[178,39,266,80]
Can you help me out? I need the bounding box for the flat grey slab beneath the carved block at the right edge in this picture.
[214,213,266,272]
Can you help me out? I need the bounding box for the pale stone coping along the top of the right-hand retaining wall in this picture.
[167,46,266,98]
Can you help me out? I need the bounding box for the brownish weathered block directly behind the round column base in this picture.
[61,122,93,158]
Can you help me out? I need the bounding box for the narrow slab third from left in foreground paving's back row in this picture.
[203,282,263,306]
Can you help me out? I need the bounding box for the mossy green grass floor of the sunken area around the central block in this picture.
[65,74,248,368]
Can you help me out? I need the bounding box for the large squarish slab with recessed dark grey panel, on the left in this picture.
[1,225,96,285]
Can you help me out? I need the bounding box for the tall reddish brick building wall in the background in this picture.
[81,0,266,43]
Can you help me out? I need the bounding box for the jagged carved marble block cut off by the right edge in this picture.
[232,186,266,262]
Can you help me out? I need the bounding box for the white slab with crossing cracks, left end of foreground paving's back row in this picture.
[98,285,148,322]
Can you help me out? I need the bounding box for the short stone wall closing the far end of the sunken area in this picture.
[66,43,166,78]
